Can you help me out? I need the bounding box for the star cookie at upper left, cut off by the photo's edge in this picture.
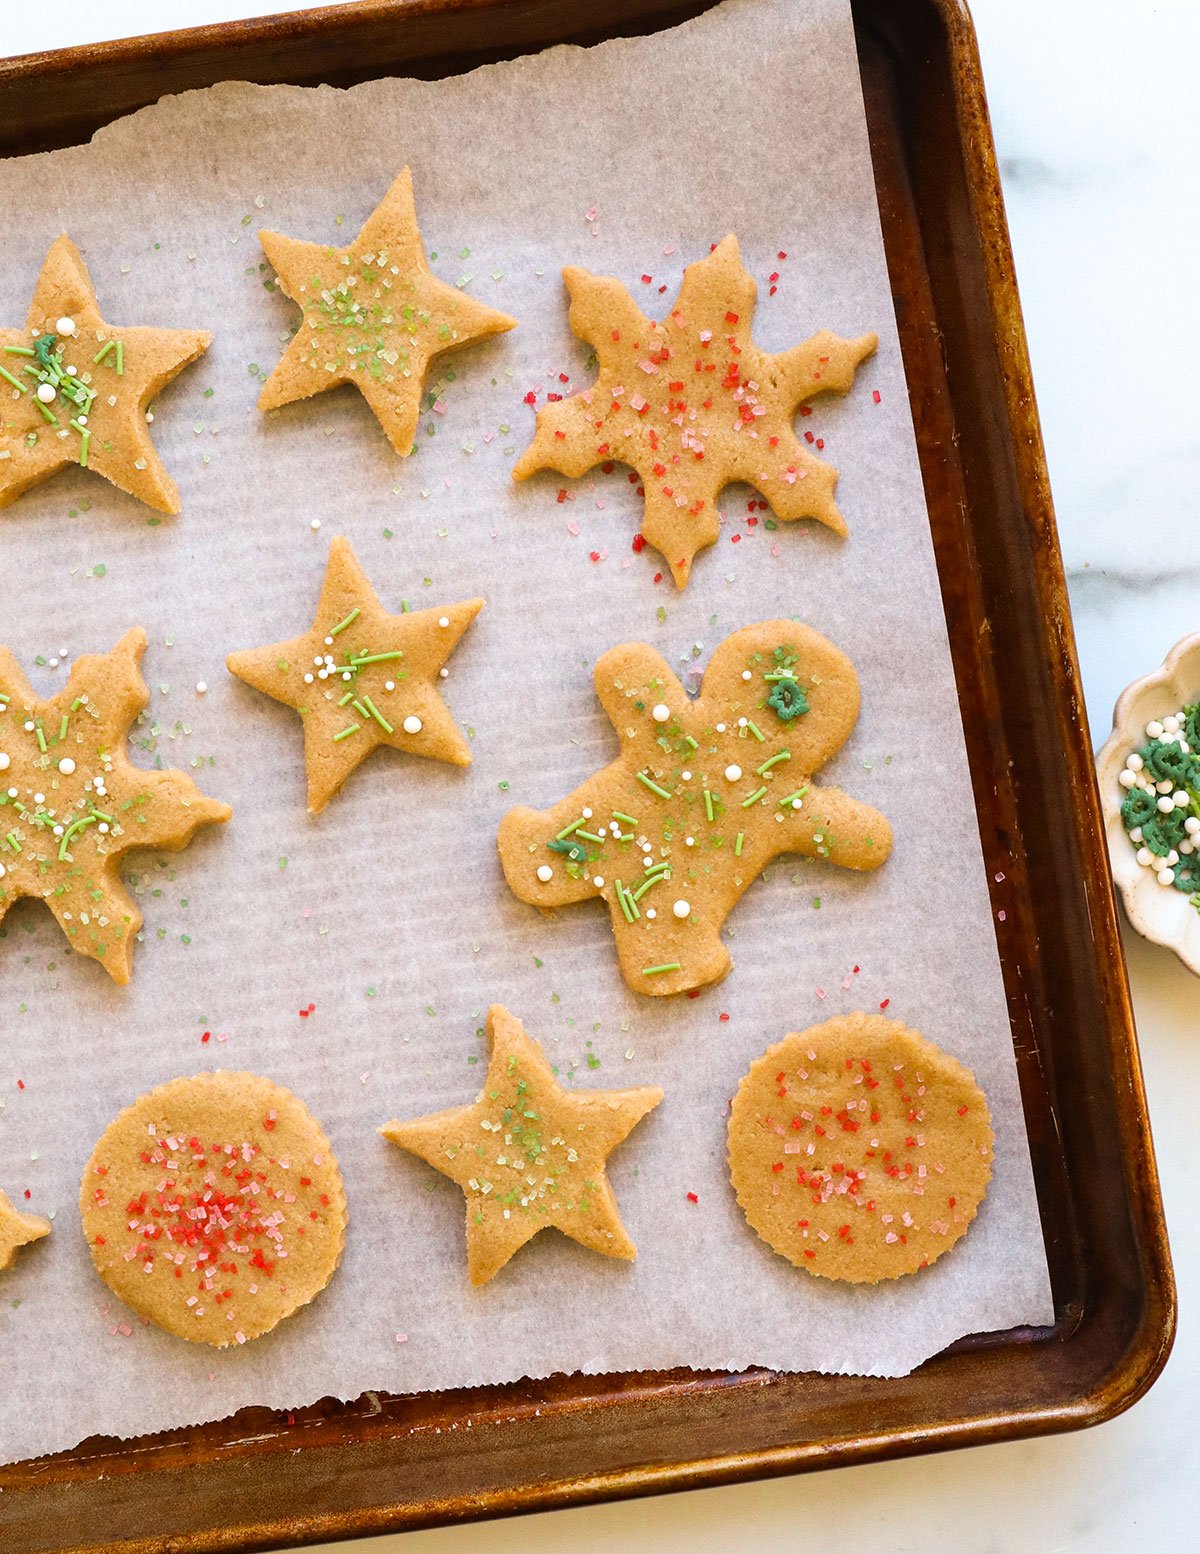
[0,236,213,513]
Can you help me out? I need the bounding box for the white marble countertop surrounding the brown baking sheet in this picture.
[0,0,1200,1554]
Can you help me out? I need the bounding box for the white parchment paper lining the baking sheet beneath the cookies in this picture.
[0,0,1052,1459]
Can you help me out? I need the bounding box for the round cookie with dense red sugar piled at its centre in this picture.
[79,1069,347,1347]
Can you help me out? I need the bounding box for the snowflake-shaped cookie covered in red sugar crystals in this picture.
[513,233,877,587]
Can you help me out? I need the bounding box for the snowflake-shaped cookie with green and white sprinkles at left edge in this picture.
[0,626,233,984]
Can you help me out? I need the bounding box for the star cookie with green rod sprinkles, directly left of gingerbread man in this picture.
[225,535,483,814]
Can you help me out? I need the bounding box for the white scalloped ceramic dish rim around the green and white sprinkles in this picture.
[1096,632,1200,976]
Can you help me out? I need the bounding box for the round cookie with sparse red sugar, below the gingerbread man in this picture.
[729,1013,995,1284]
